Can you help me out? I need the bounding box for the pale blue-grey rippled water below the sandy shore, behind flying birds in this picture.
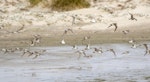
[0,44,150,82]
